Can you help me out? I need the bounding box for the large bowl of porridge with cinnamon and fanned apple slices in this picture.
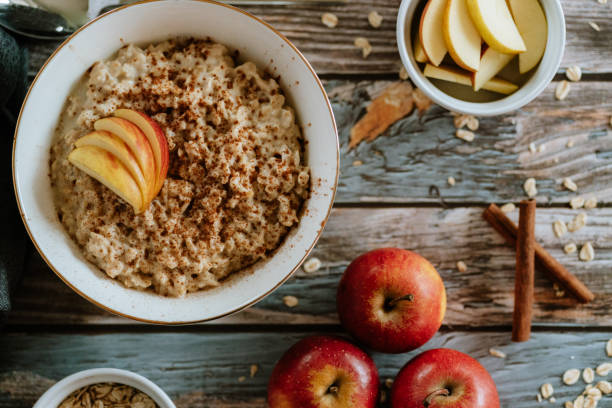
[13,0,339,324]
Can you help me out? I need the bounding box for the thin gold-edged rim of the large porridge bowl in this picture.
[11,0,340,326]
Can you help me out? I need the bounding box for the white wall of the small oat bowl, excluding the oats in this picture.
[32,368,176,408]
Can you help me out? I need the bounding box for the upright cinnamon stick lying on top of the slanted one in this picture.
[512,200,536,341]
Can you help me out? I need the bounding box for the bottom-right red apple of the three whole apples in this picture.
[391,349,500,408]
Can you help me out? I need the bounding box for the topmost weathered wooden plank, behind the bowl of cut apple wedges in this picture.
[23,0,612,74]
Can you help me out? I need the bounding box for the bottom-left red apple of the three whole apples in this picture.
[268,336,378,408]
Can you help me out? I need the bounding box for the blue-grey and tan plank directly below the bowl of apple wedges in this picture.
[327,81,612,204]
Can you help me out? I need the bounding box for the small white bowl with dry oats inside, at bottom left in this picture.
[33,368,175,408]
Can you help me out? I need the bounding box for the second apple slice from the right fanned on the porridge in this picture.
[94,117,157,205]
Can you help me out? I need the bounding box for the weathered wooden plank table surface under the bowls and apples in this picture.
[0,0,612,408]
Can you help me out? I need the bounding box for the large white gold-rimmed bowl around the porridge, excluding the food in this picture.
[13,0,339,324]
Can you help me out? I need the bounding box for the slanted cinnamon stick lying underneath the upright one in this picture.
[482,204,595,303]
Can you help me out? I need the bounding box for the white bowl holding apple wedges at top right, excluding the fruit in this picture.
[397,0,565,116]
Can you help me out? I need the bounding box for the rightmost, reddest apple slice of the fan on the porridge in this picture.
[113,109,170,197]
